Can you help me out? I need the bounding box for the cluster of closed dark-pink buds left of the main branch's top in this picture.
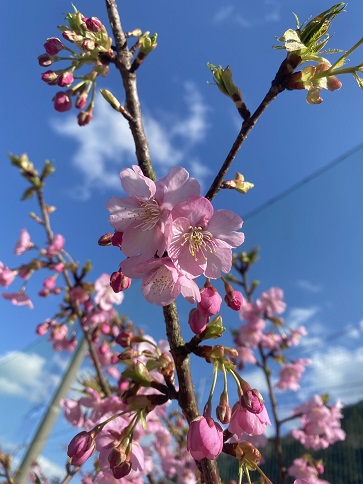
[38,8,114,126]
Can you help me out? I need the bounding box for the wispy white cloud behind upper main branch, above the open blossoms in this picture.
[52,82,208,200]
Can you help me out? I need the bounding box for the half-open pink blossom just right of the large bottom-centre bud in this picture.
[228,402,271,437]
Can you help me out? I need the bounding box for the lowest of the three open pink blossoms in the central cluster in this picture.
[120,257,200,306]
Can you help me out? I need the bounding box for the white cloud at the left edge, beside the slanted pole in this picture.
[0,351,59,402]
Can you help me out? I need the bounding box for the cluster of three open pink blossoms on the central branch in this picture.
[106,166,244,306]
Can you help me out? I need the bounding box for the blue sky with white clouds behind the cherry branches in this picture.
[0,0,363,480]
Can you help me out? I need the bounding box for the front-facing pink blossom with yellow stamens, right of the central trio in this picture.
[165,197,244,279]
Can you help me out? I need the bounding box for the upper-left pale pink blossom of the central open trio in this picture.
[106,165,200,260]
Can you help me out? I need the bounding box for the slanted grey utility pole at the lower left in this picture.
[14,338,88,484]
